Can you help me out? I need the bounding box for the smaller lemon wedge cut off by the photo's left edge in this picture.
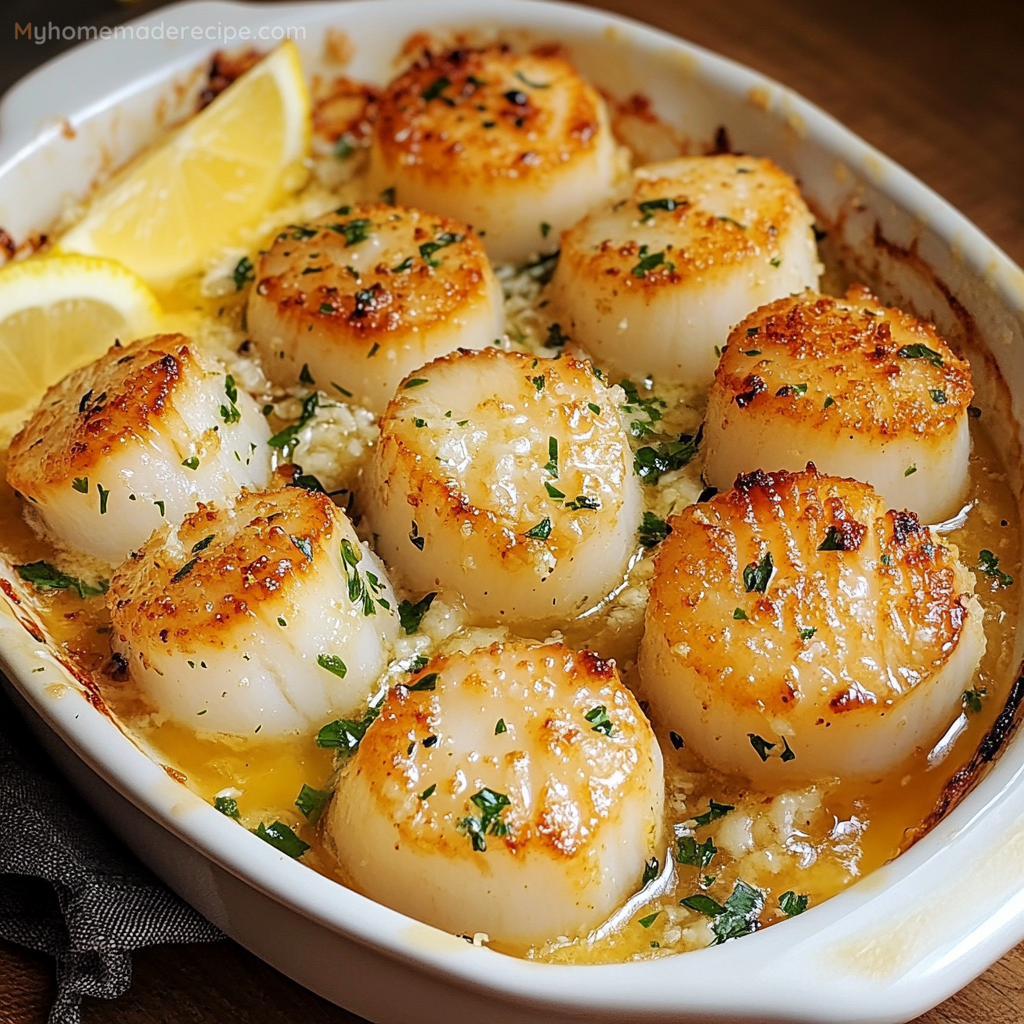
[0,255,161,428]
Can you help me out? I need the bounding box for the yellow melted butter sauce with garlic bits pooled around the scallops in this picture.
[0,153,1024,964]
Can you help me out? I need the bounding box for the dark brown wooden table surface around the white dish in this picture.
[0,0,1024,1024]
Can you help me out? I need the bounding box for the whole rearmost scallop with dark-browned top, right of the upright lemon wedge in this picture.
[370,46,623,262]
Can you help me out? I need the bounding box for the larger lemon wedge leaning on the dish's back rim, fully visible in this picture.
[58,41,310,289]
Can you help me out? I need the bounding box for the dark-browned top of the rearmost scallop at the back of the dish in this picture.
[374,45,606,188]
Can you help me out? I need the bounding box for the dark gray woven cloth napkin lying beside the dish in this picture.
[0,688,223,1024]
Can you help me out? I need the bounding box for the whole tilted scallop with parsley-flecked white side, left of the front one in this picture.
[108,487,398,738]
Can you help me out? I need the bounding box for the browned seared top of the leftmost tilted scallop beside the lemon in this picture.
[7,334,214,497]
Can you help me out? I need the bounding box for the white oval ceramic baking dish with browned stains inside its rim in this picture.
[0,0,1024,1024]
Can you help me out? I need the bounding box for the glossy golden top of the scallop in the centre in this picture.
[381,348,632,561]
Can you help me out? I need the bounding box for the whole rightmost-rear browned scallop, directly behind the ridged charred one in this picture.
[705,287,973,522]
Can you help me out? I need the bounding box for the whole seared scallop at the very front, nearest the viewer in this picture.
[325,641,664,945]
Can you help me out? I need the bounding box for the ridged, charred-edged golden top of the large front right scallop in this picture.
[647,465,974,713]
